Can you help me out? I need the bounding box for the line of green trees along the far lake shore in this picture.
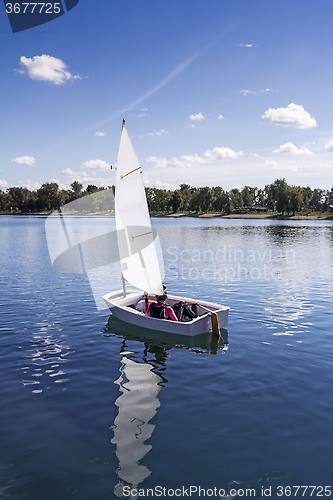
[0,179,333,216]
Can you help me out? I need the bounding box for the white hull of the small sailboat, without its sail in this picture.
[103,290,230,337]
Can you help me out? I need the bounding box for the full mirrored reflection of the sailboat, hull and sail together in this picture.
[104,316,229,498]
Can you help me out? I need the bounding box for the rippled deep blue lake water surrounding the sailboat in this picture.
[0,216,333,500]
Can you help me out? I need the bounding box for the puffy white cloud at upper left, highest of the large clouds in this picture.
[19,54,80,85]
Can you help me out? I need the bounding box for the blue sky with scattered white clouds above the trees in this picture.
[0,0,333,190]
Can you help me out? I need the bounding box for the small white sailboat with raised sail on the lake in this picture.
[103,120,229,336]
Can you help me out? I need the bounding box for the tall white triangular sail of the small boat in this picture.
[115,123,163,294]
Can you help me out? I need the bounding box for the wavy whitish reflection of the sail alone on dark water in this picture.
[111,351,163,497]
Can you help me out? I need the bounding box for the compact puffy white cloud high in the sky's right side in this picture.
[262,103,317,129]
